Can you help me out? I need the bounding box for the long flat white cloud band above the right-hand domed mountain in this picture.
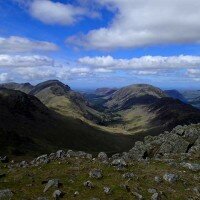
[78,55,200,70]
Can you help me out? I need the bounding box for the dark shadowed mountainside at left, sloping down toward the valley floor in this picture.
[0,88,132,156]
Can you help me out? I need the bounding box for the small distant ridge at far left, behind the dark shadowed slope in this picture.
[0,82,34,93]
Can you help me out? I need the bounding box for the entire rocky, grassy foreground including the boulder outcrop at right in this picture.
[0,124,200,200]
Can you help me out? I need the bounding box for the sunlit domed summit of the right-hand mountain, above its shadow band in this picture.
[106,84,166,110]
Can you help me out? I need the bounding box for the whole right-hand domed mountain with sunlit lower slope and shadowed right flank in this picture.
[104,84,200,134]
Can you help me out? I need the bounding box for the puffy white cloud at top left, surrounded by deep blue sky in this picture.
[29,0,99,25]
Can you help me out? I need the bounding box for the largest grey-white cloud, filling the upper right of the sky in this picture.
[66,0,200,50]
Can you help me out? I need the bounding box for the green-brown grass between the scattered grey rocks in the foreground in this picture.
[0,158,200,200]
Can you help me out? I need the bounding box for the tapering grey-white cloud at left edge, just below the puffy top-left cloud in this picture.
[0,36,58,54]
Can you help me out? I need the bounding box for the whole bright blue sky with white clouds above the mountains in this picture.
[0,0,200,89]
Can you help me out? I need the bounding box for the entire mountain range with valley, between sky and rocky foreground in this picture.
[0,80,200,156]
